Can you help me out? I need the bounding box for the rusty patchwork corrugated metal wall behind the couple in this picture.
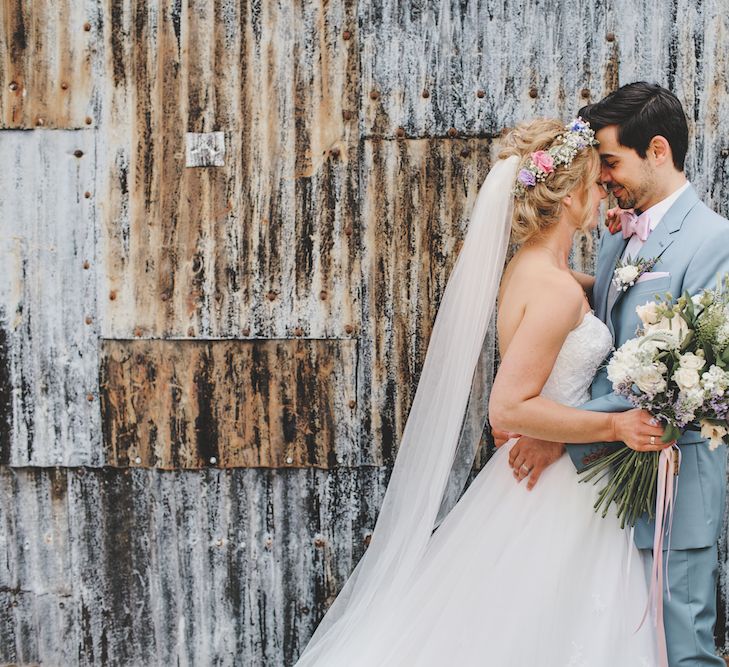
[0,0,729,665]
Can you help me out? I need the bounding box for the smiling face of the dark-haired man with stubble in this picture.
[595,125,656,209]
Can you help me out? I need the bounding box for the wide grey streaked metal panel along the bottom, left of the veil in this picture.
[0,468,386,665]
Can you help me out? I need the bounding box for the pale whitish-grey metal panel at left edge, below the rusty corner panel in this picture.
[0,130,102,465]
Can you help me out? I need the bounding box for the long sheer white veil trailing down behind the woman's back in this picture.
[297,156,519,667]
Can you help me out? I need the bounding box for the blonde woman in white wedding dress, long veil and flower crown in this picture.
[297,119,664,667]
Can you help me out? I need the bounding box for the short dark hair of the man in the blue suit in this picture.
[579,81,688,171]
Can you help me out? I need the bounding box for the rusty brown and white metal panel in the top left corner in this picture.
[0,0,99,129]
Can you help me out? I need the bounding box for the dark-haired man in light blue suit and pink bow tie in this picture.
[498,82,729,667]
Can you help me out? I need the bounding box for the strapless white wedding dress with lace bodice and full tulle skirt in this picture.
[304,313,656,667]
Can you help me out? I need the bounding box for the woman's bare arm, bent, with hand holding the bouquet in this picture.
[489,281,664,451]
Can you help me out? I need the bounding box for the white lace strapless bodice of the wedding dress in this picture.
[542,312,613,406]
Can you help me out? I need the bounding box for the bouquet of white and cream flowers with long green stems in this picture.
[582,274,729,526]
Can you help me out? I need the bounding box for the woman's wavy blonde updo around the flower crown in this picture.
[499,119,600,245]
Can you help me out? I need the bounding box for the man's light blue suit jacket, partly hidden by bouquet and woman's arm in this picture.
[567,187,729,549]
